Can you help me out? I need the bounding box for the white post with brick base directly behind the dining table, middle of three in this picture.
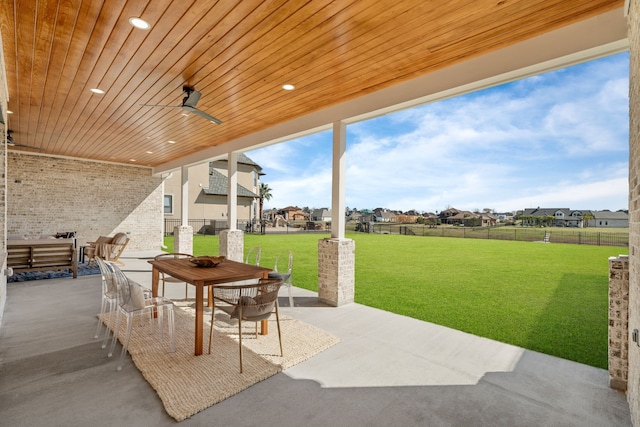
[220,152,244,262]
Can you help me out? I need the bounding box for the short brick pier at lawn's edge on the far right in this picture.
[609,255,638,391]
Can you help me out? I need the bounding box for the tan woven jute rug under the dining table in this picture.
[100,301,340,421]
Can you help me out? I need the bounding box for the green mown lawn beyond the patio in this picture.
[165,233,626,369]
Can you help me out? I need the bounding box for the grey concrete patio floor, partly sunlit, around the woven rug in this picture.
[0,253,631,427]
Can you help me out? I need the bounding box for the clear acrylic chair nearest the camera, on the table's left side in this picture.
[109,263,176,371]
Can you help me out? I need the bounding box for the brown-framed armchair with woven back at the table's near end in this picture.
[209,279,283,373]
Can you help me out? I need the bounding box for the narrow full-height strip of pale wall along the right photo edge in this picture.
[627,0,640,426]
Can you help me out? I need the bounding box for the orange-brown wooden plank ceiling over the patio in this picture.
[0,0,624,166]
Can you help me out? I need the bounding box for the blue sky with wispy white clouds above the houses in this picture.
[245,53,629,212]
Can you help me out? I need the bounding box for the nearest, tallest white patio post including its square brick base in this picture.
[318,122,356,307]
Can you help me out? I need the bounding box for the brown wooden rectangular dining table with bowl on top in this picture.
[149,258,271,356]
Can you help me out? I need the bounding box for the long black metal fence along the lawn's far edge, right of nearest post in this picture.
[364,223,629,247]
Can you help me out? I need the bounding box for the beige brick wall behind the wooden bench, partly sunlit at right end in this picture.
[7,152,163,250]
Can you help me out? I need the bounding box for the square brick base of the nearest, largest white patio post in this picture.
[318,238,356,307]
